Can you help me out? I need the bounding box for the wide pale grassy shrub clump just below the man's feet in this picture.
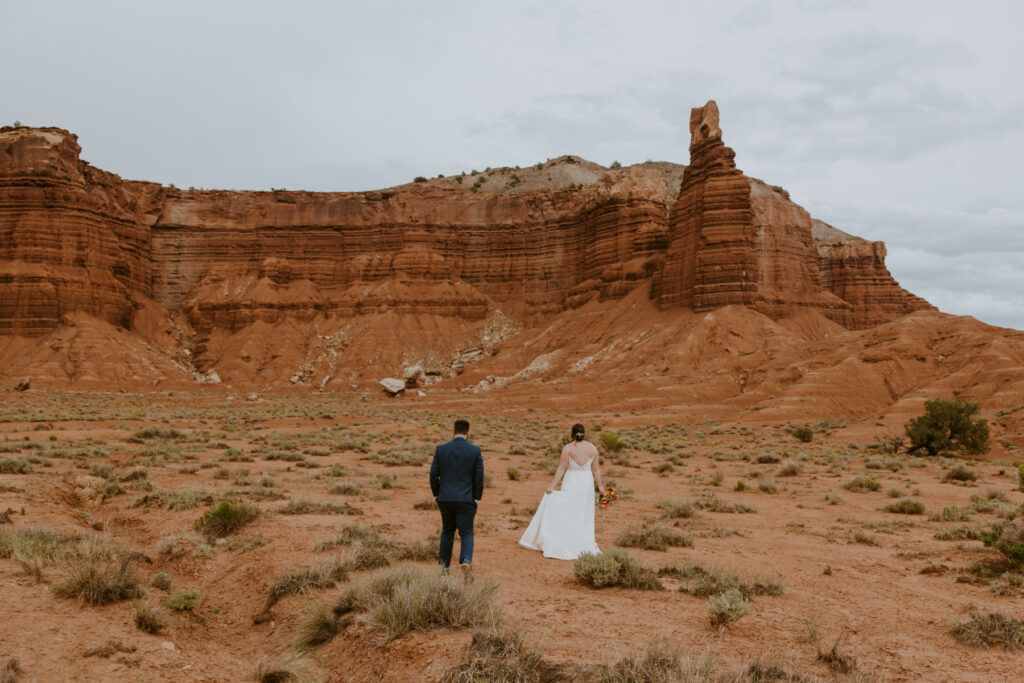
[334,566,500,640]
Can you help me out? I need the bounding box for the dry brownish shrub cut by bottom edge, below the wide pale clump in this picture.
[441,625,554,683]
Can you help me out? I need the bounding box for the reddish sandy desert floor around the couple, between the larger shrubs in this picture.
[0,390,1024,681]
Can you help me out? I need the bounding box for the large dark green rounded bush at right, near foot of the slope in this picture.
[904,398,990,456]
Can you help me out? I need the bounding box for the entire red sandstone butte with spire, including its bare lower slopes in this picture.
[0,101,1024,440]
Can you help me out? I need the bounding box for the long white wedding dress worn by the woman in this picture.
[519,458,601,560]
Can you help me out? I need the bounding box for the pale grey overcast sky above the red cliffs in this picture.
[0,0,1024,329]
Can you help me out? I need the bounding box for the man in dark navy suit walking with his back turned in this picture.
[430,420,483,577]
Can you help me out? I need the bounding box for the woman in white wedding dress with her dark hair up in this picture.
[519,424,604,560]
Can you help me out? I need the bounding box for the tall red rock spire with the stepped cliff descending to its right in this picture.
[652,101,933,329]
